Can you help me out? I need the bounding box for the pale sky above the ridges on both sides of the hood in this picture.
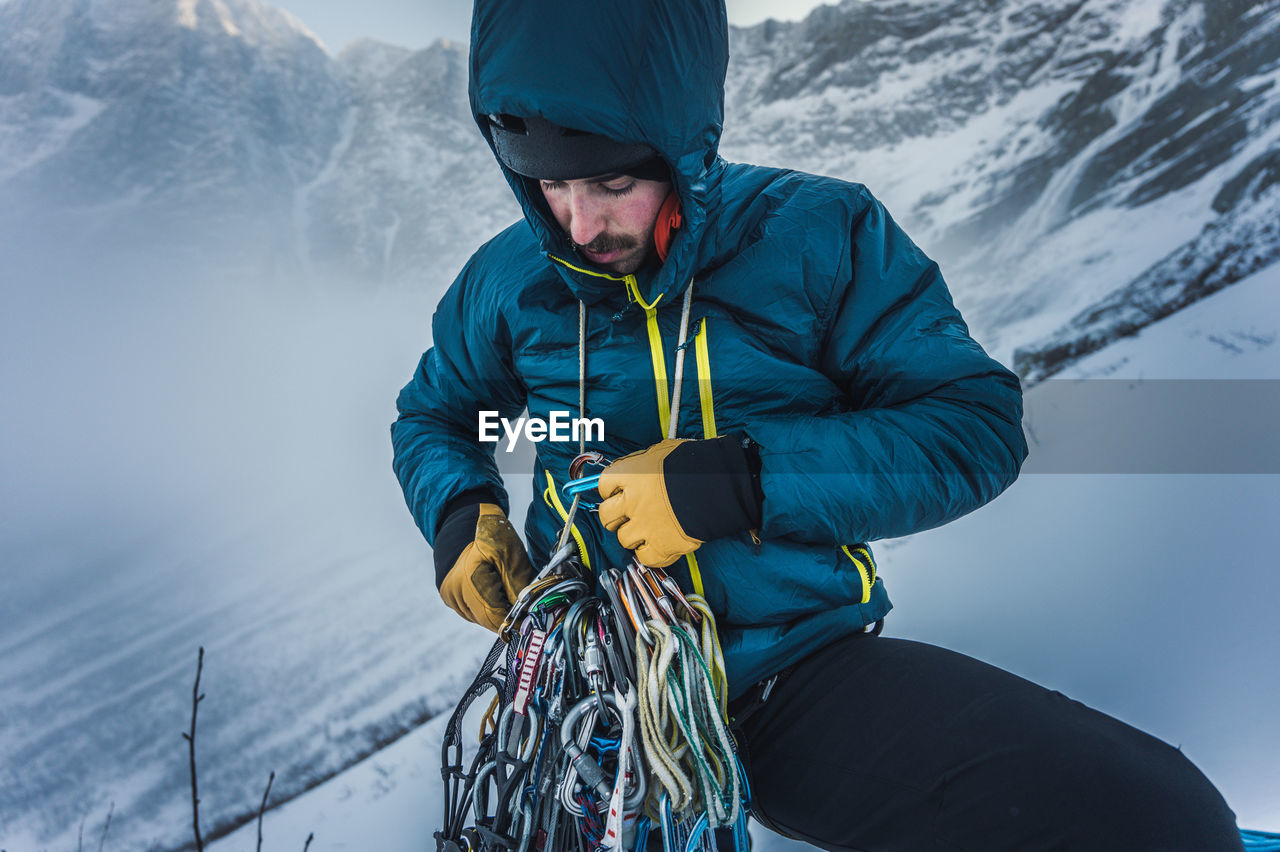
[269,0,822,52]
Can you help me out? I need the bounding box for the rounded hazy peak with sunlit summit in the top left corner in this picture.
[0,0,347,235]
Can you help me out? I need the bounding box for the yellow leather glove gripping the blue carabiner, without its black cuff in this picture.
[599,438,703,568]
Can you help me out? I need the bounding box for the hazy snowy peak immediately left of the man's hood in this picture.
[298,41,520,281]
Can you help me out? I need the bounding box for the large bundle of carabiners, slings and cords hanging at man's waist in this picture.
[435,453,749,852]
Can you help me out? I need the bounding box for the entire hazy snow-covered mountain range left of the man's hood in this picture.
[0,0,517,283]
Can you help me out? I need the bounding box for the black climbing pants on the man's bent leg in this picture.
[731,633,1243,852]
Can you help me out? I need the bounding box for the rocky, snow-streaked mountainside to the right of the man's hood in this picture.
[724,0,1280,370]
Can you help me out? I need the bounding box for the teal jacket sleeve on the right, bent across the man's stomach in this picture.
[746,189,1027,544]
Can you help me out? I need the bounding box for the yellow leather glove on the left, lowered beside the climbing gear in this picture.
[440,503,534,633]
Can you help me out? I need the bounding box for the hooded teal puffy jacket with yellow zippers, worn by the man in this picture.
[392,0,1027,696]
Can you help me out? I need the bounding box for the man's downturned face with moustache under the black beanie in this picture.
[539,174,671,275]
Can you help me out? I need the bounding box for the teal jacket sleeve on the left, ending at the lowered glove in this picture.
[392,258,526,544]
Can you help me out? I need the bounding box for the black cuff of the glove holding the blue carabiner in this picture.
[662,432,764,541]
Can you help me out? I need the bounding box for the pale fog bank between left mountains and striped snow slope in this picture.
[0,235,424,601]
